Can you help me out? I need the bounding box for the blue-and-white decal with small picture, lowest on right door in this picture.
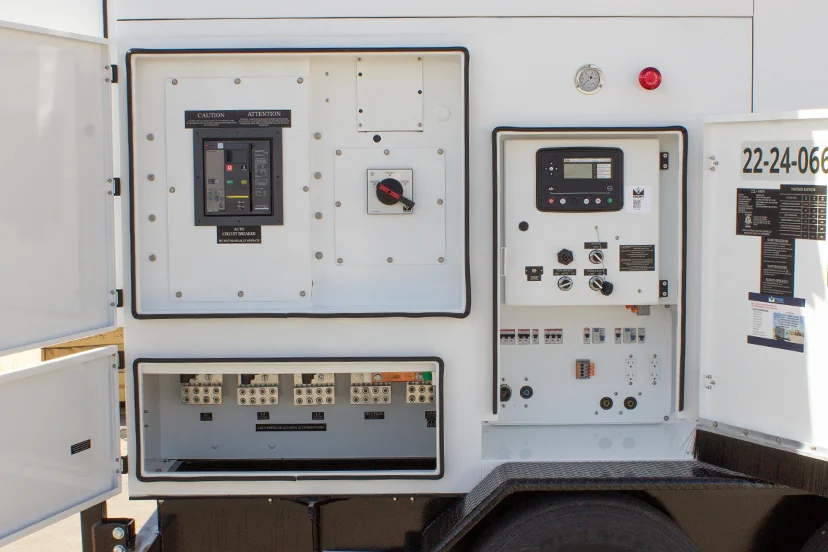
[747,293,805,353]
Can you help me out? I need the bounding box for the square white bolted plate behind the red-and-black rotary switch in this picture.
[334,148,447,266]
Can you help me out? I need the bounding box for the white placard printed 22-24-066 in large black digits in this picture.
[741,141,828,182]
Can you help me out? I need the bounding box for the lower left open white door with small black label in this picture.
[0,347,121,547]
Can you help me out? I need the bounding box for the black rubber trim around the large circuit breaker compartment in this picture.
[125,46,472,320]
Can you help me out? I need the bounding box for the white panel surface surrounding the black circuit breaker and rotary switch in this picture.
[128,49,467,318]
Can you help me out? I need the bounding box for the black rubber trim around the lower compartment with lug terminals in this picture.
[132,356,446,483]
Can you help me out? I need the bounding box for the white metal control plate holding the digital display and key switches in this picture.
[501,133,660,306]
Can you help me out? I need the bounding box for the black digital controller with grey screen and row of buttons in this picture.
[537,147,624,212]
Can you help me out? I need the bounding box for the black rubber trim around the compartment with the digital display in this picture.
[492,125,689,414]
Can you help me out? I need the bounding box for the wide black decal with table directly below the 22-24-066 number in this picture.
[736,184,828,241]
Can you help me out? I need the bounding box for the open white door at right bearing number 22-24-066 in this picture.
[697,111,828,495]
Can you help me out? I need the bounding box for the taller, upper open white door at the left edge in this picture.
[0,22,116,354]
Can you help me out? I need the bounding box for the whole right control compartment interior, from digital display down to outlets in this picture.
[493,129,685,425]
